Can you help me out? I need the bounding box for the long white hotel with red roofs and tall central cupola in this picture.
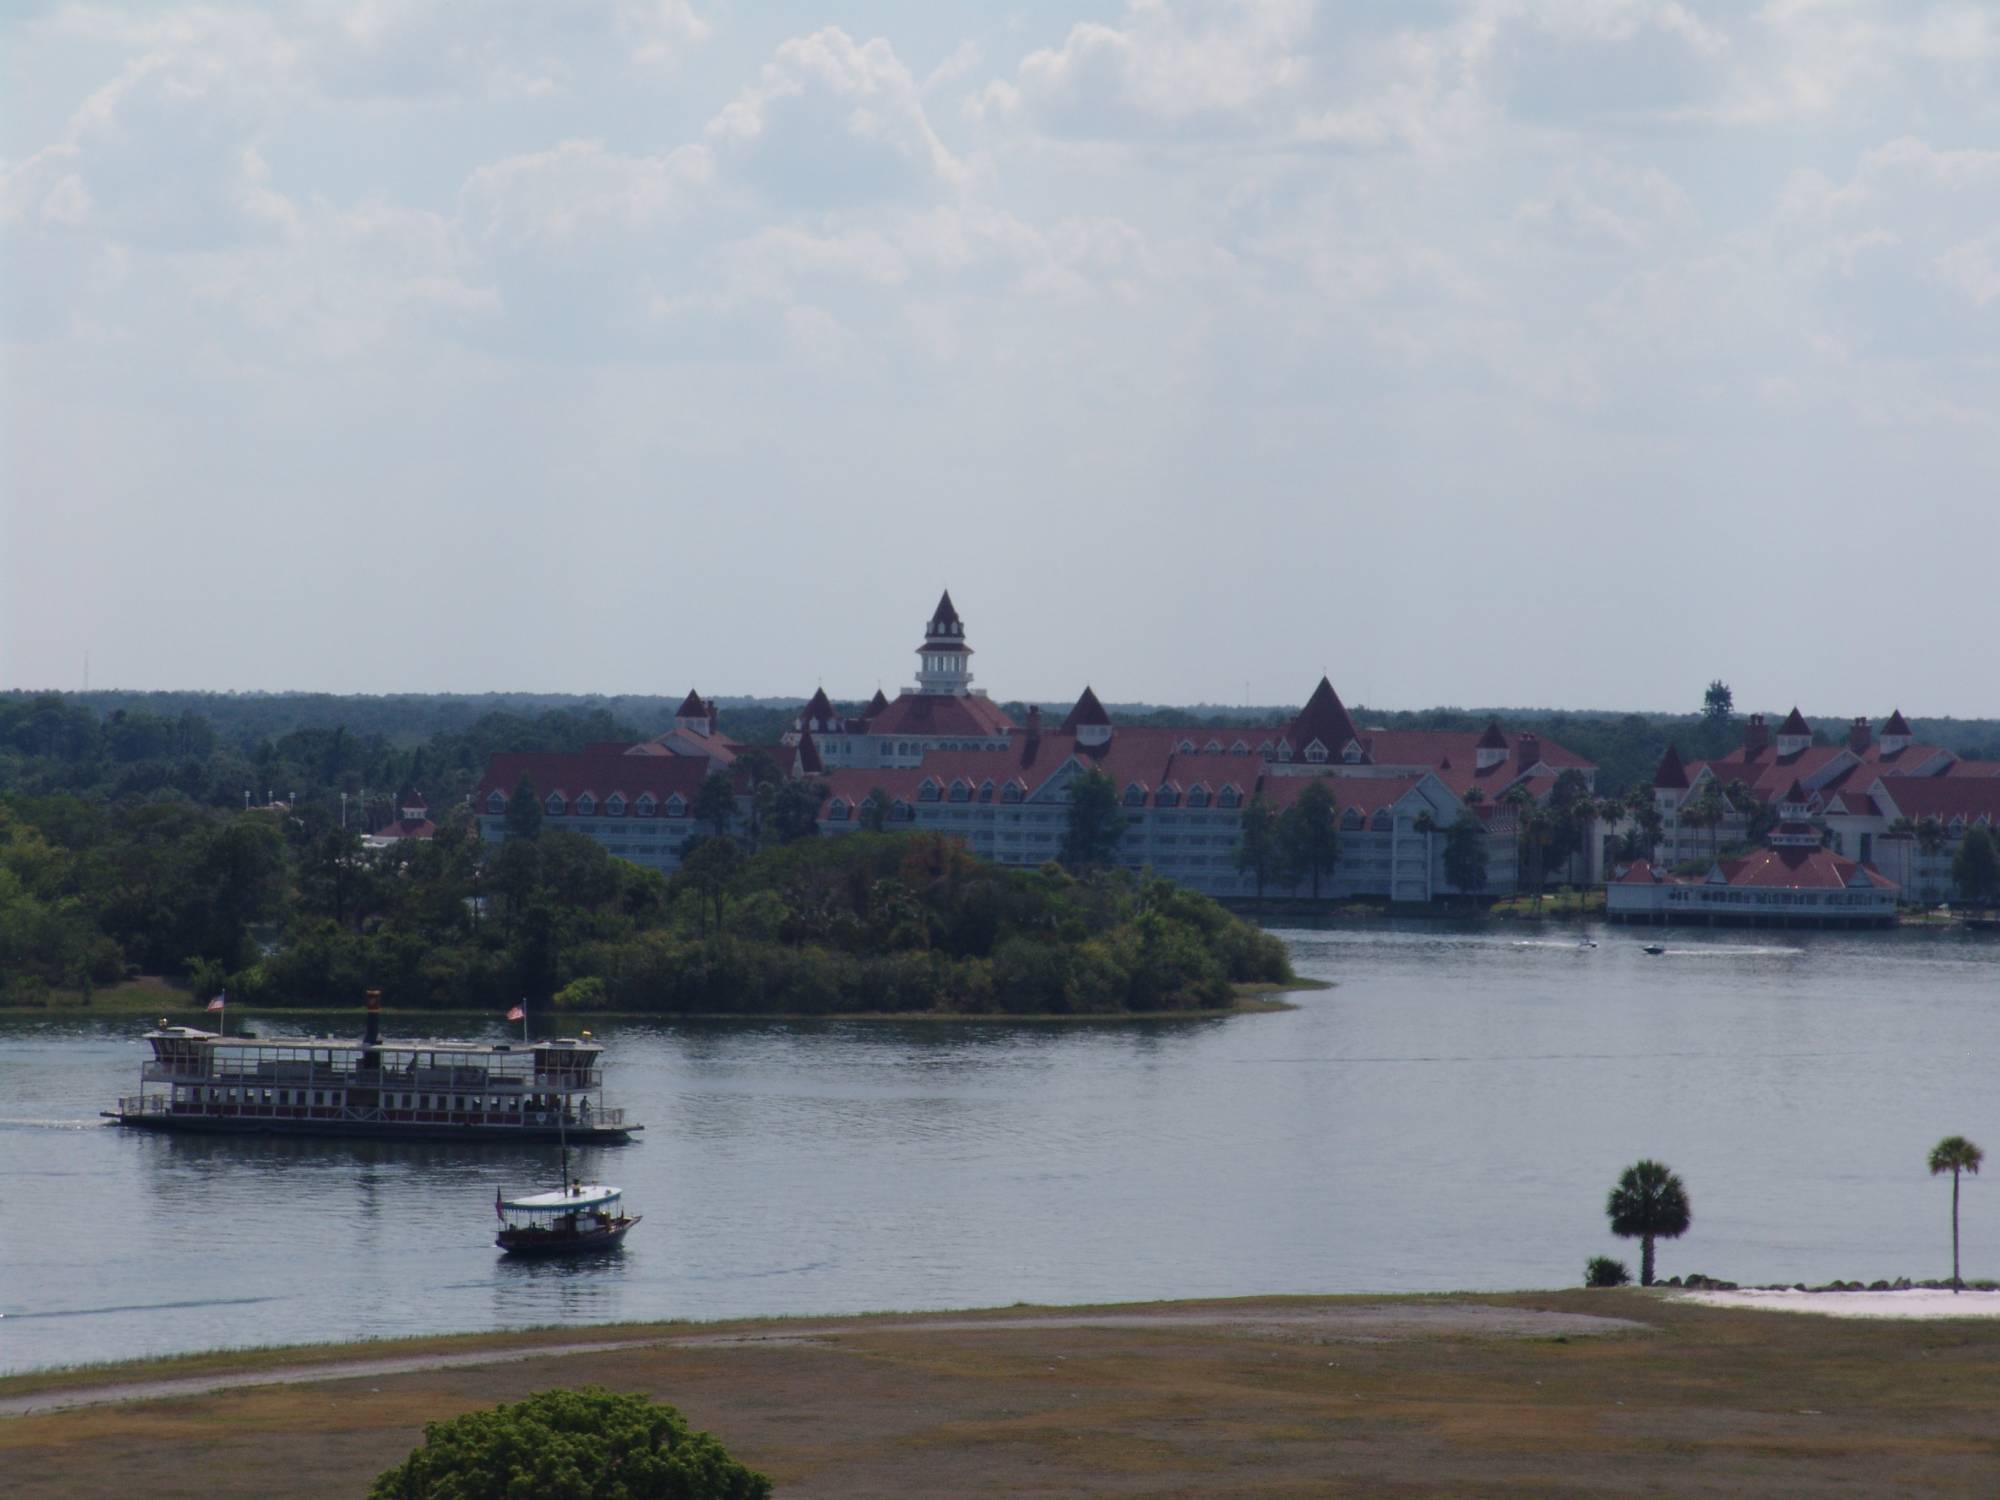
[474,594,1598,902]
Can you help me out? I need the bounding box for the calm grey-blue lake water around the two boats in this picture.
[0,926,2000,1370]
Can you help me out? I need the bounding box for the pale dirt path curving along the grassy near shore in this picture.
[0,1302,1646,1418]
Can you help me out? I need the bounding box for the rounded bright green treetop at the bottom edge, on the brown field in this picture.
[368,1386,770,1500]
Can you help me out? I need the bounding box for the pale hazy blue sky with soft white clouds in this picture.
[0,0,2000,716]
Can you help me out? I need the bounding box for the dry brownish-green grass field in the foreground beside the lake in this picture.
[0,1290,2000,1500]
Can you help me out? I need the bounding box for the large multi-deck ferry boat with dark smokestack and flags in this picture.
[104,990,644,1144]
